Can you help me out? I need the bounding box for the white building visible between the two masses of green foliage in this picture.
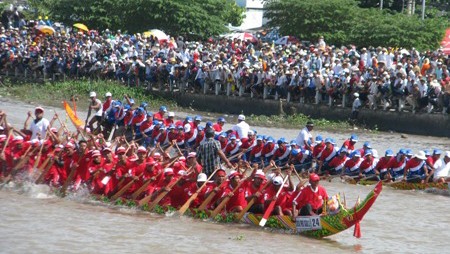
[236,0,267,30]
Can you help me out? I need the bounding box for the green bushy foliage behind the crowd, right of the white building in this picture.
[266,0,449,50]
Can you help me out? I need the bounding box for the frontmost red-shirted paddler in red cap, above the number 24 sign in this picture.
[293,173,328,216]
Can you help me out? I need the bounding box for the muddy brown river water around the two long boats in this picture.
[0,98,450,253]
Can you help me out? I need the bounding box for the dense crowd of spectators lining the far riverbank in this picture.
[0,16,450,114]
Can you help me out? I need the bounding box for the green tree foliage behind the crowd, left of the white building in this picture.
[30,0,244,37]
